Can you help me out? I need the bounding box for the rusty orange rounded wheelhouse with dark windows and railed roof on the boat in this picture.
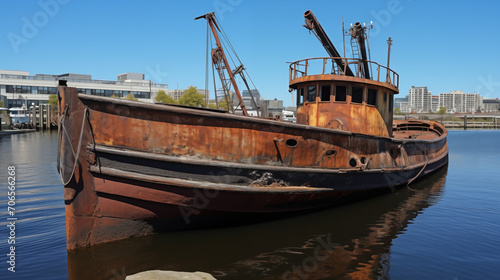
[289,58,399,137]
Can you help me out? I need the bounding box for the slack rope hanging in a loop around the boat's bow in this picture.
[57,105,88,186]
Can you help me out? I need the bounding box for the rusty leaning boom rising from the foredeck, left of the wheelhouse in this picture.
[195,12,251,116]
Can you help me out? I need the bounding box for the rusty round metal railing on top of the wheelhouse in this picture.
[289,57,399,88]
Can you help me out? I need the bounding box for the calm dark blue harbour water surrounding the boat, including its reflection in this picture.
[0,131,500,280]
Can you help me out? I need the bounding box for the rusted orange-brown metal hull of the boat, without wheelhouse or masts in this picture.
[59,86,448,249]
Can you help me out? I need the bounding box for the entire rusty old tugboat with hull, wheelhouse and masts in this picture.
[58,11,448,250]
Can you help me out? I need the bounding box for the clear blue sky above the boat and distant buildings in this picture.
[0,0,500,105]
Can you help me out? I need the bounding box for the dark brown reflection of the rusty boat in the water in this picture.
[68,167,447,280]
